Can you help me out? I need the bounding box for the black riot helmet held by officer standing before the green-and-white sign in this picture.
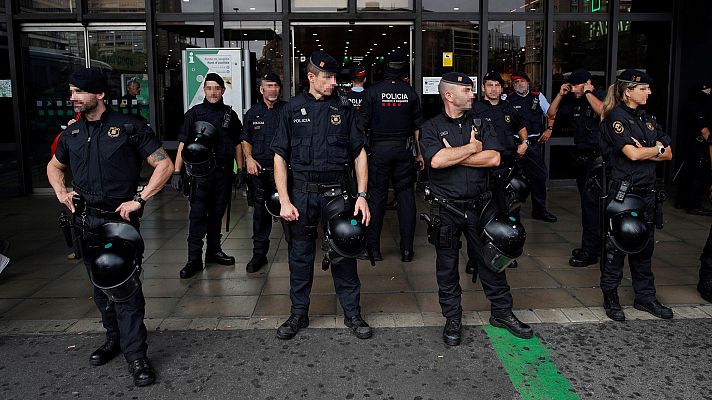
[181,121,217,177]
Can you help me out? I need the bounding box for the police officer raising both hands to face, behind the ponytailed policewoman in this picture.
[547,69,605,267]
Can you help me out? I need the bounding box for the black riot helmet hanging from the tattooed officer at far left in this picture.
[87,222,144,303]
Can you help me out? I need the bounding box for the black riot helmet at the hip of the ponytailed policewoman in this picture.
[608,210,650,254]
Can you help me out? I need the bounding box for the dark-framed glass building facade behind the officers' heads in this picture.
[0,0,684,193]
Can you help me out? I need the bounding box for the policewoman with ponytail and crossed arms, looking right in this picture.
[600,69,673,321]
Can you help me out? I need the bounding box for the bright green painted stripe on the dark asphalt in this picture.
[484,325,579,400]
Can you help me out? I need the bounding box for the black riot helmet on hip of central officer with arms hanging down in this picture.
[322,197,368,258]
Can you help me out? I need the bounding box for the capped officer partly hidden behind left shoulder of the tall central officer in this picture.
[242,72,287,273]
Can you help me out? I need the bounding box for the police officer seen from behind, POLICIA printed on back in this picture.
[359,50,423,262]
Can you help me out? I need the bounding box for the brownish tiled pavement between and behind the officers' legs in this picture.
[0,188,712,333]
